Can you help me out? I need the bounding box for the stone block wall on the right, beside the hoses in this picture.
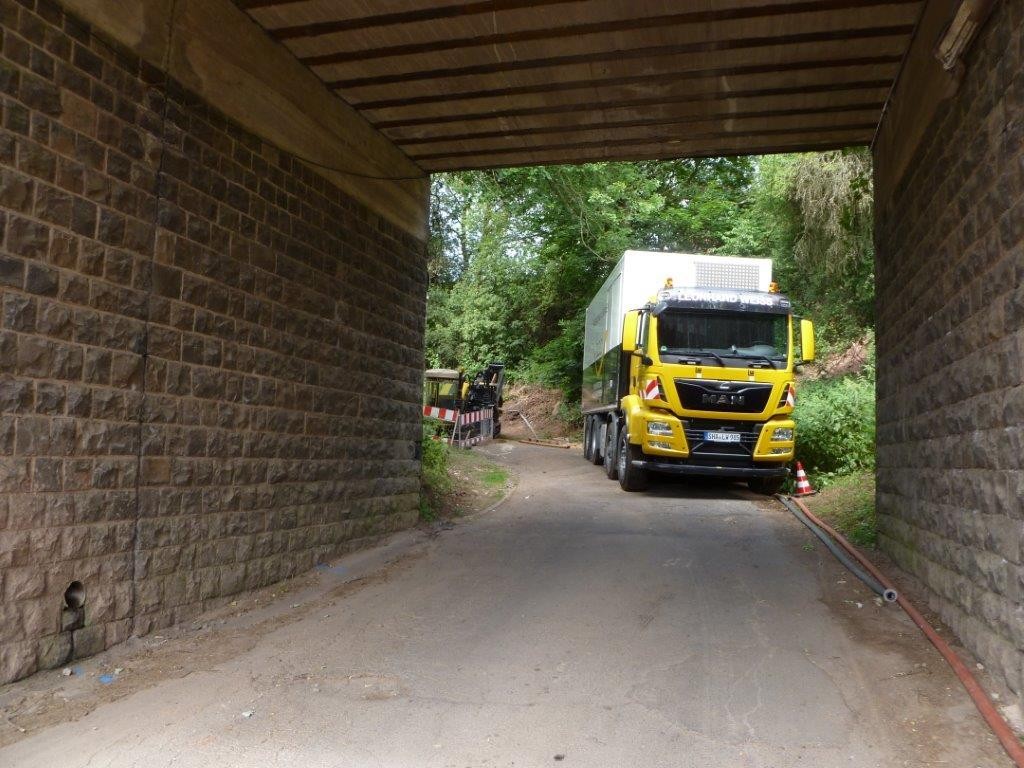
[876,0,1024,694]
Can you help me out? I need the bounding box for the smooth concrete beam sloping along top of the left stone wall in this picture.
[63,0,429,240]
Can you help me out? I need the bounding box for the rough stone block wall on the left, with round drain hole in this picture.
[0,0,426,682]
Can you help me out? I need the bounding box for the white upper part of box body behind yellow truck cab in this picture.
[583,251,771,367]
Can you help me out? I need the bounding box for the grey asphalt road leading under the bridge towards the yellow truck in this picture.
[0,442,1008,768]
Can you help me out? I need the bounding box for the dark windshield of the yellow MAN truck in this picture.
[657,310,788,368]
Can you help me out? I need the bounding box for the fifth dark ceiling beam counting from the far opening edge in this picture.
[303,25,913,83]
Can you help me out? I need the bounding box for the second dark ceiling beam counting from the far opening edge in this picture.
[392,99,883,148]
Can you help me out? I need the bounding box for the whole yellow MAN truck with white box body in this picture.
[583,251,814,494]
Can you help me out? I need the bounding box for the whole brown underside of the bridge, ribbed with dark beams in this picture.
[236,0,922,171]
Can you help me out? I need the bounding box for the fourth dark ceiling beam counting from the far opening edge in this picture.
[342,54,903,110]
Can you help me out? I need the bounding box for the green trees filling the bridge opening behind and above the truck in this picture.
[426,150,874,401]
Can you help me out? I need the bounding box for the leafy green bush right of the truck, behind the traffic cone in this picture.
[795,376,874,475]
